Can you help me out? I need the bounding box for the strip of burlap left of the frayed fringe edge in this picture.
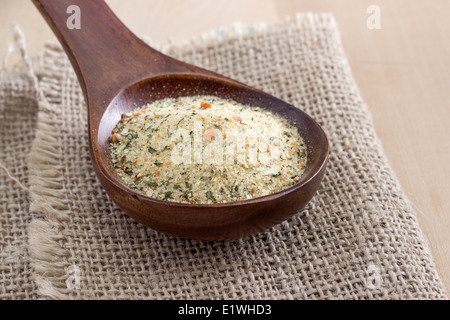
[0,70,37,300]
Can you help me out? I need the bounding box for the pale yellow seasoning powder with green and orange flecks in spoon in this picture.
[110,96,307,203]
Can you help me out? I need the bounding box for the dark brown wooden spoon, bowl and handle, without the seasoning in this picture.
[33,0,328,240]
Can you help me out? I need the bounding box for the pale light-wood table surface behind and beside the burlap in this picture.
[0,0,450,293]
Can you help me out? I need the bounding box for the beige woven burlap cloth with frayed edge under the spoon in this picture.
[0,14,446,299]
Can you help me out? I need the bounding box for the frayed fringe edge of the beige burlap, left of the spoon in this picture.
[12,25,73,299]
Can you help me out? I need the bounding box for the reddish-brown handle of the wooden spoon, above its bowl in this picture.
[32,0,199,106]
